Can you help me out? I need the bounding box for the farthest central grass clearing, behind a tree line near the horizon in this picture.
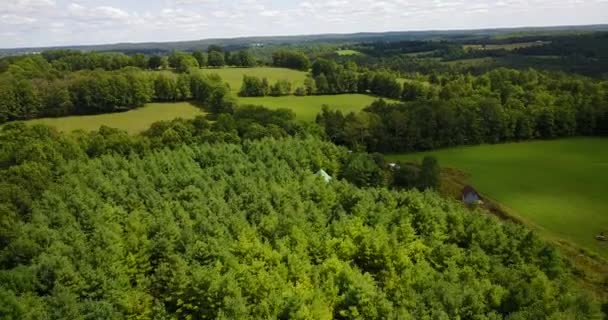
[201,67,307,93]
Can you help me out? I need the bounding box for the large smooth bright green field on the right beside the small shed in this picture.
[388,138,608,258]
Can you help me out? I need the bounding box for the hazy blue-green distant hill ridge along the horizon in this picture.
[0,25,608,56]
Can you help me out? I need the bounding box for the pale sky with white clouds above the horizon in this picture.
[0,0,608,48]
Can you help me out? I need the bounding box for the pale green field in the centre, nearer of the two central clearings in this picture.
[239,94,388,121]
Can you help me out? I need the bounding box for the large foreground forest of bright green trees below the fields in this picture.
[0,119,602,320]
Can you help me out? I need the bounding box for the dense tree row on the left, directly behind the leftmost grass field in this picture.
[0,69,236,123]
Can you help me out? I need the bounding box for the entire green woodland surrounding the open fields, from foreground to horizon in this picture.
[0,33,608,320]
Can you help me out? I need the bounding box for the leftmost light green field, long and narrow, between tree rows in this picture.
[27,102,205,134]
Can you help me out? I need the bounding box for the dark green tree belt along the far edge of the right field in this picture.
[317,69,608,152]
